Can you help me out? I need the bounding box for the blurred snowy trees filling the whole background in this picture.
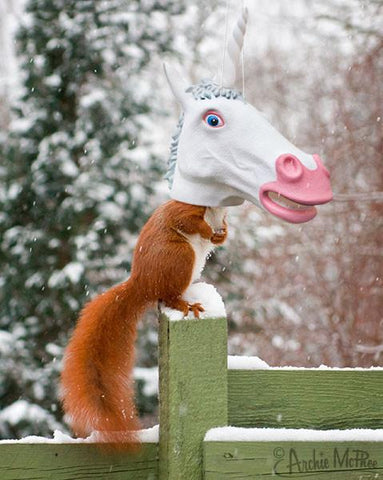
[0,0,383,438]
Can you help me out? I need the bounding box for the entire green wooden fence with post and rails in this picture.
[0,314,383,480]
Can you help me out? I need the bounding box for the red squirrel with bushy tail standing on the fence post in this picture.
[61,200,227,446]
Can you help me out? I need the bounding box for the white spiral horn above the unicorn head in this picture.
[222,8,249,87]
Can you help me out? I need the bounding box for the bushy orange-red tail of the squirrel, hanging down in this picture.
[61,279,148,448]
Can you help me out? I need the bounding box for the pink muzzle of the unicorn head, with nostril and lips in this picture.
[259,153,333,223]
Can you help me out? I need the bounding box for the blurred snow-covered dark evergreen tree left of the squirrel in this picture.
[0,0,183,437]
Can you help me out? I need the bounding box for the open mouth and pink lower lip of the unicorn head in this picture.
[261,190,317,223]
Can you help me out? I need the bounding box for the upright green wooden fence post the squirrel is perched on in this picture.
[159,315,227,480]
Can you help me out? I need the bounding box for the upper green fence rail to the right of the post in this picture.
[228,370,383,429]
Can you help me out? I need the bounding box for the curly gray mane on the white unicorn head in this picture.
[165,80,243,188]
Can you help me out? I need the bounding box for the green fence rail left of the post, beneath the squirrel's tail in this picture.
[0,443,158,480]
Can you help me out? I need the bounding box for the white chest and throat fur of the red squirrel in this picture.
[185,207,226,282]
